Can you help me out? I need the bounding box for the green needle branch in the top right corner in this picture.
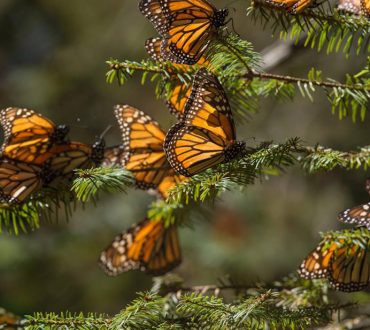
[248,0,370,55]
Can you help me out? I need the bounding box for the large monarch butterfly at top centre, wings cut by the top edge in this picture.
[139,0,228,64]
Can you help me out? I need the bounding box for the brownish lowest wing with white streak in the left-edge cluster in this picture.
[0,159,45,206]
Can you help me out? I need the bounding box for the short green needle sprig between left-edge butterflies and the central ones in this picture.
[72,167,134,202]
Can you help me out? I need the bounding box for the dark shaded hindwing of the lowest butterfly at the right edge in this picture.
[328,243,370,292]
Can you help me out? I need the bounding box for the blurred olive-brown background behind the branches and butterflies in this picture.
[0,0,370,314]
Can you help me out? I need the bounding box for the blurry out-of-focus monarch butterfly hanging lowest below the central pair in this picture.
[99,219,181,276]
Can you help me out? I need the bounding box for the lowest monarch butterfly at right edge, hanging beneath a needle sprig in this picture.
[298,235,370,292]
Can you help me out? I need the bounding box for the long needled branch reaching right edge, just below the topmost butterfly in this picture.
[107,47,370,121]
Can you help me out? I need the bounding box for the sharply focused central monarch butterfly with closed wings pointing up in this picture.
[164,68,245,177]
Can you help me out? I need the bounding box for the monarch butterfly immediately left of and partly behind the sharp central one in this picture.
[110,105,185,198]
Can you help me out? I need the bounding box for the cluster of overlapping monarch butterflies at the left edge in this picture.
[0,108,104,208]
